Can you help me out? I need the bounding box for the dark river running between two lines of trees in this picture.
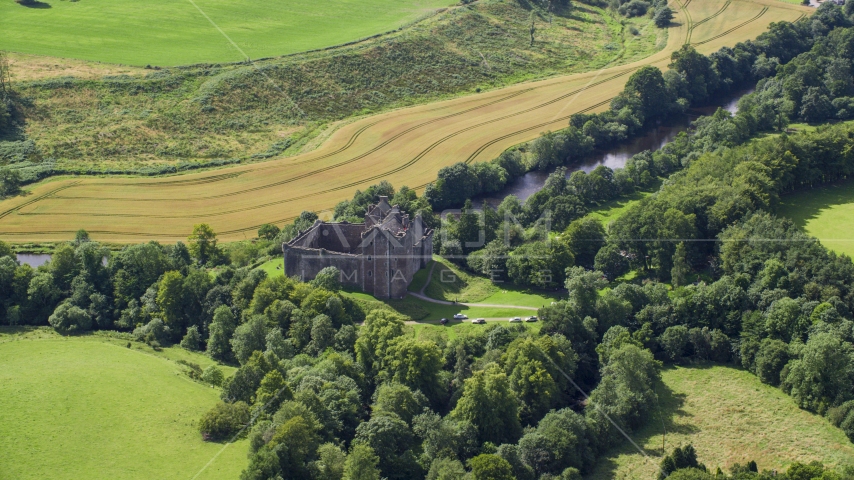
[472,88,754,208]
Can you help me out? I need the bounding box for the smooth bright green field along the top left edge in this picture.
[0,0,451,66]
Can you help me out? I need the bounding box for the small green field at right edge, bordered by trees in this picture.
[777,182,854,257]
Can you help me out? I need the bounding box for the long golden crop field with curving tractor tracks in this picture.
[0,0,810,243]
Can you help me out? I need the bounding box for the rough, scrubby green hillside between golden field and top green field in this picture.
[0,0,666,172]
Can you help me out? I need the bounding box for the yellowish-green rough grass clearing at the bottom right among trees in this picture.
[589,366,854,480]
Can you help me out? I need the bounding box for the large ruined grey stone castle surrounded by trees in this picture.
[282,197,433,298]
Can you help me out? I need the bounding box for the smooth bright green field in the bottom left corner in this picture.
[0,328,248,480]
